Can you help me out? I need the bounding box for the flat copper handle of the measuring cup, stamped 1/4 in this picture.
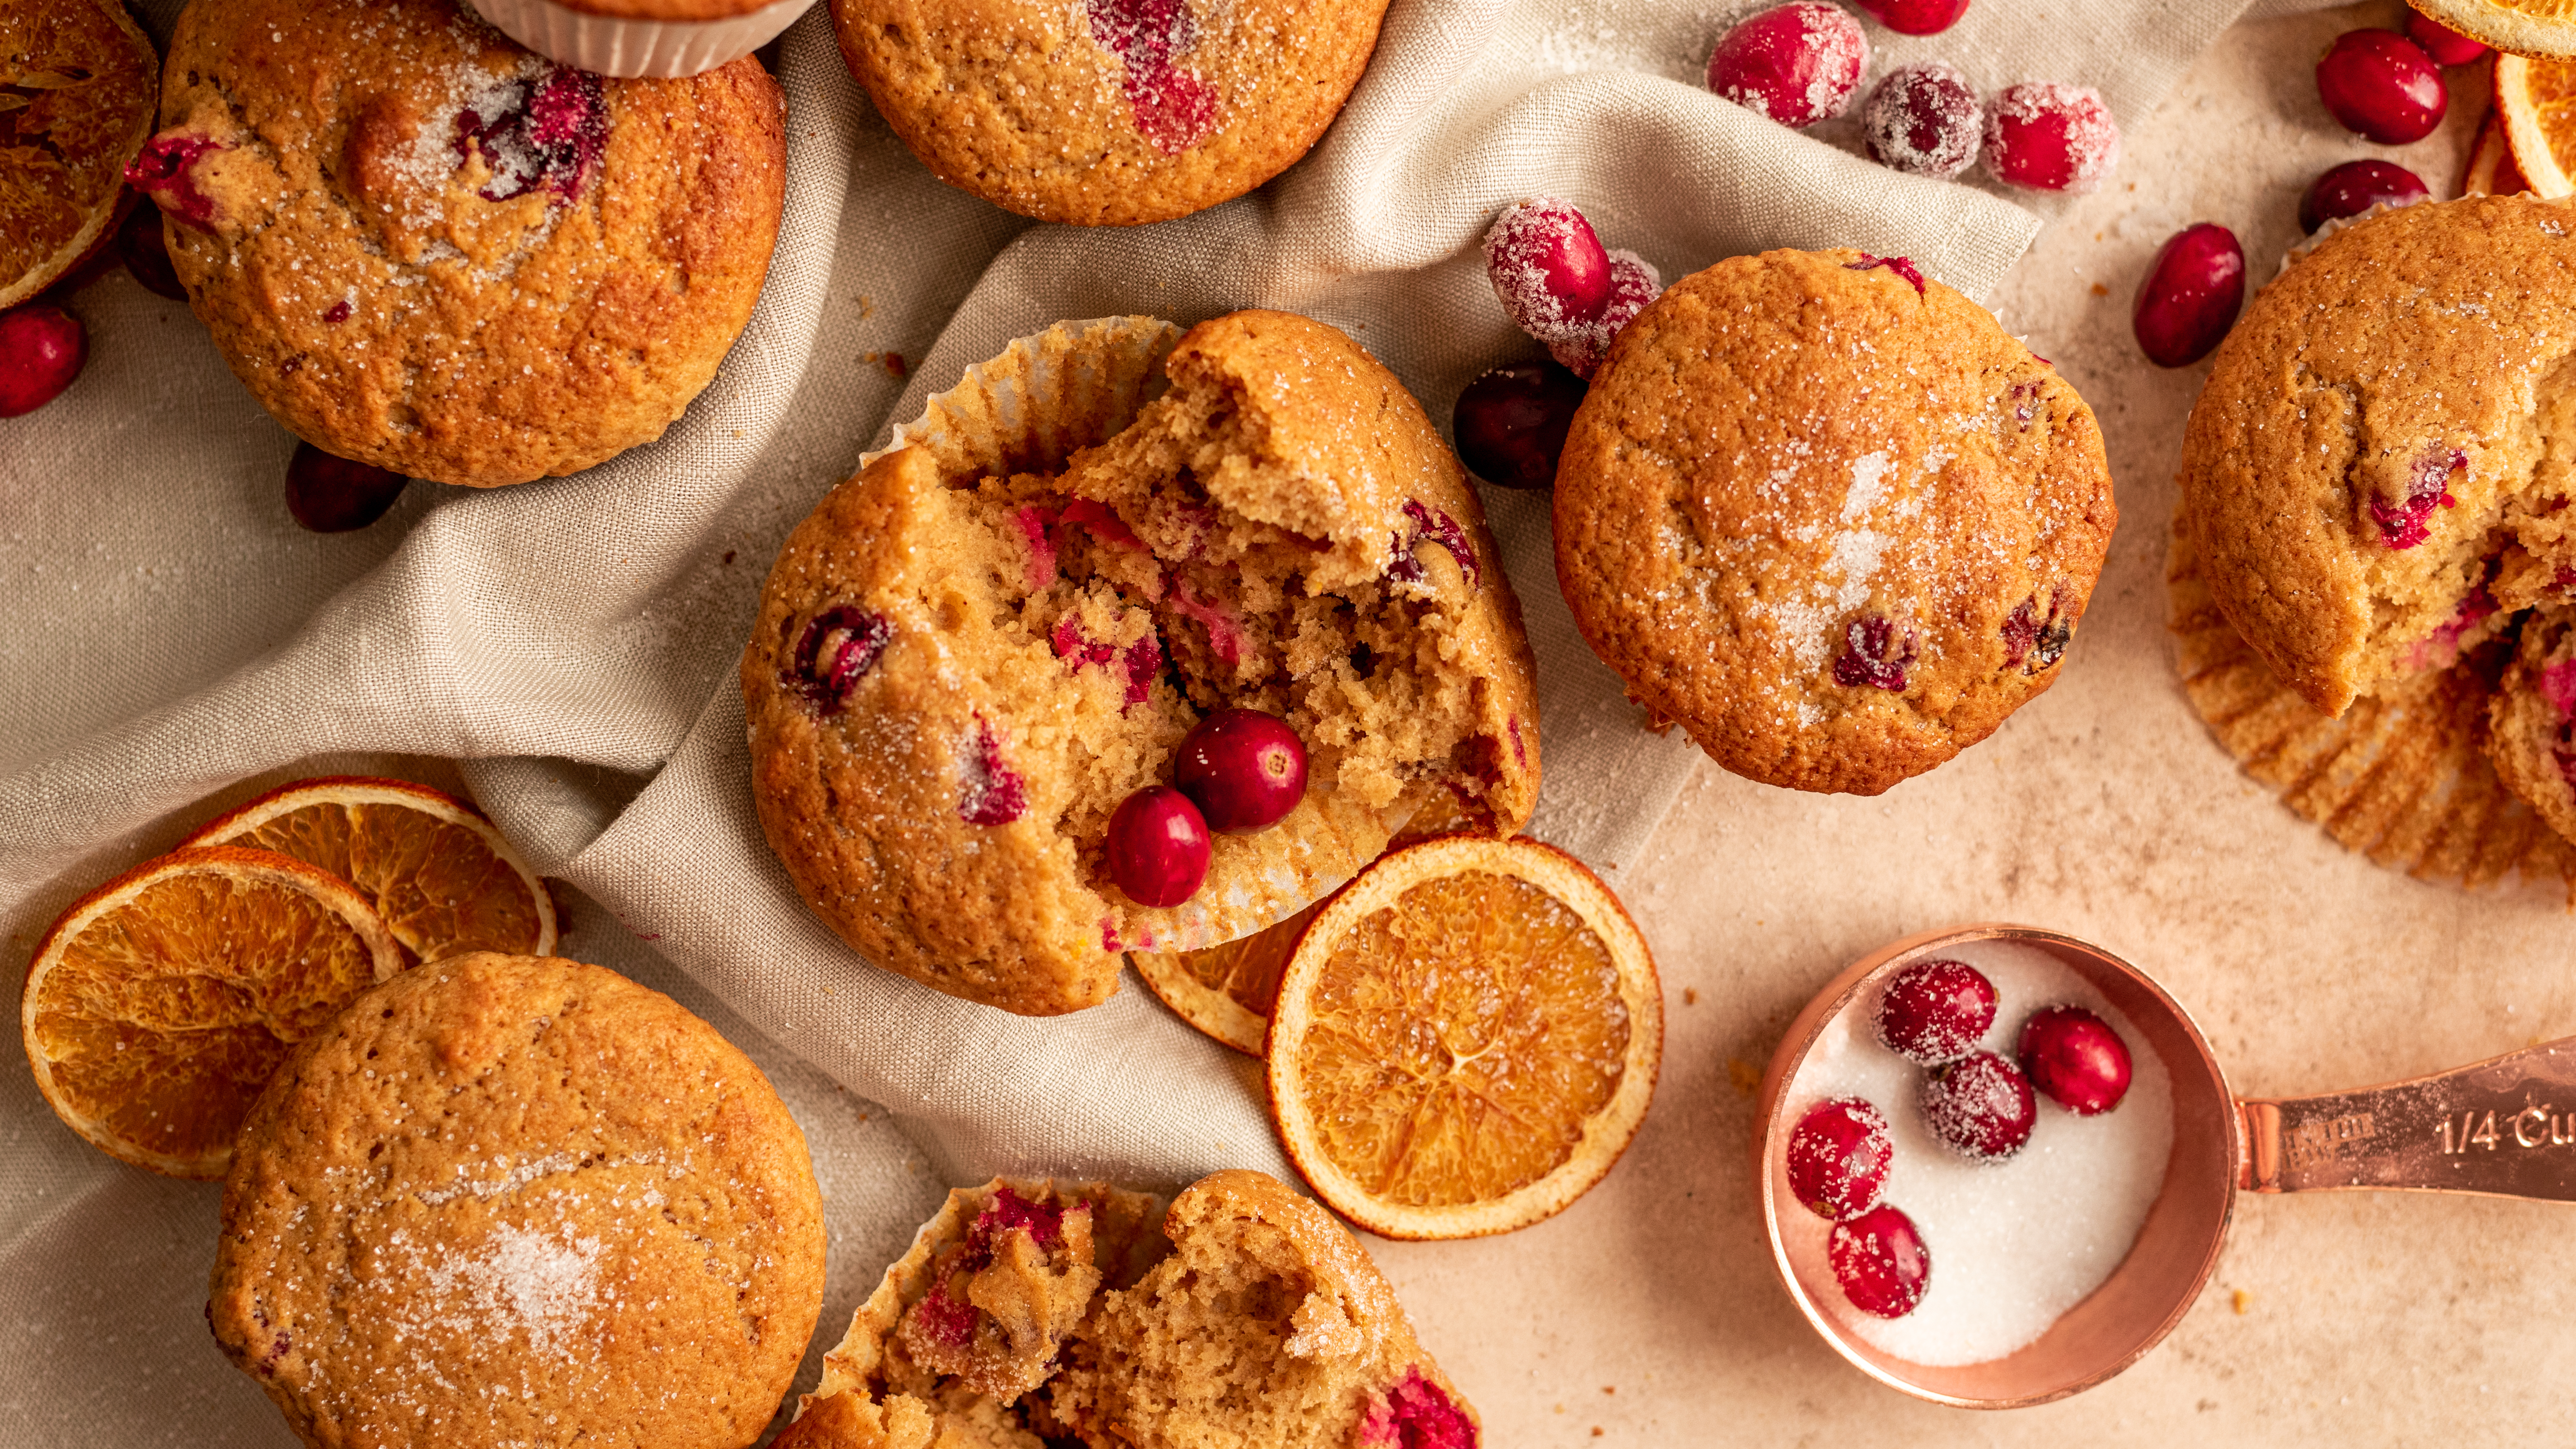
[2236,1036,2576,1201]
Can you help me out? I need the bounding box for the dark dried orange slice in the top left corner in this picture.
[0,0,160,307]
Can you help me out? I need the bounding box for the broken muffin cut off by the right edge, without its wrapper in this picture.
[2177,196,2576,714]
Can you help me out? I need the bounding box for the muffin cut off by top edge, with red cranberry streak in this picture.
[832,0,1386,227]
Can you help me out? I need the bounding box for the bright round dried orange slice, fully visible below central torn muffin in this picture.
[1267,835,1664,1238]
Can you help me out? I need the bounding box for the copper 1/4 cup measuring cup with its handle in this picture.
[1754,926,2576,1408]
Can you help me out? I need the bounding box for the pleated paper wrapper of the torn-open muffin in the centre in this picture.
[860,317,1412,951]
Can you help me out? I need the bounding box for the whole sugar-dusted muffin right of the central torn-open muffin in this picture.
[1556,250,2117,794]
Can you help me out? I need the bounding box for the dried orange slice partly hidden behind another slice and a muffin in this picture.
[188,776,554,962]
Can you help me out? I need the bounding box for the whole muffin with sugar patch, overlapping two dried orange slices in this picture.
[206,954,824,1449]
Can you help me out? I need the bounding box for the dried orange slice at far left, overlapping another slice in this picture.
[18,846,402,1178]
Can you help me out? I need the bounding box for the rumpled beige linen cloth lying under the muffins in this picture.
[0,0,2300,1446]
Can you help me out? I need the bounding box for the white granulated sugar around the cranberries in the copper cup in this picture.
[1780,941,2174,1367]
